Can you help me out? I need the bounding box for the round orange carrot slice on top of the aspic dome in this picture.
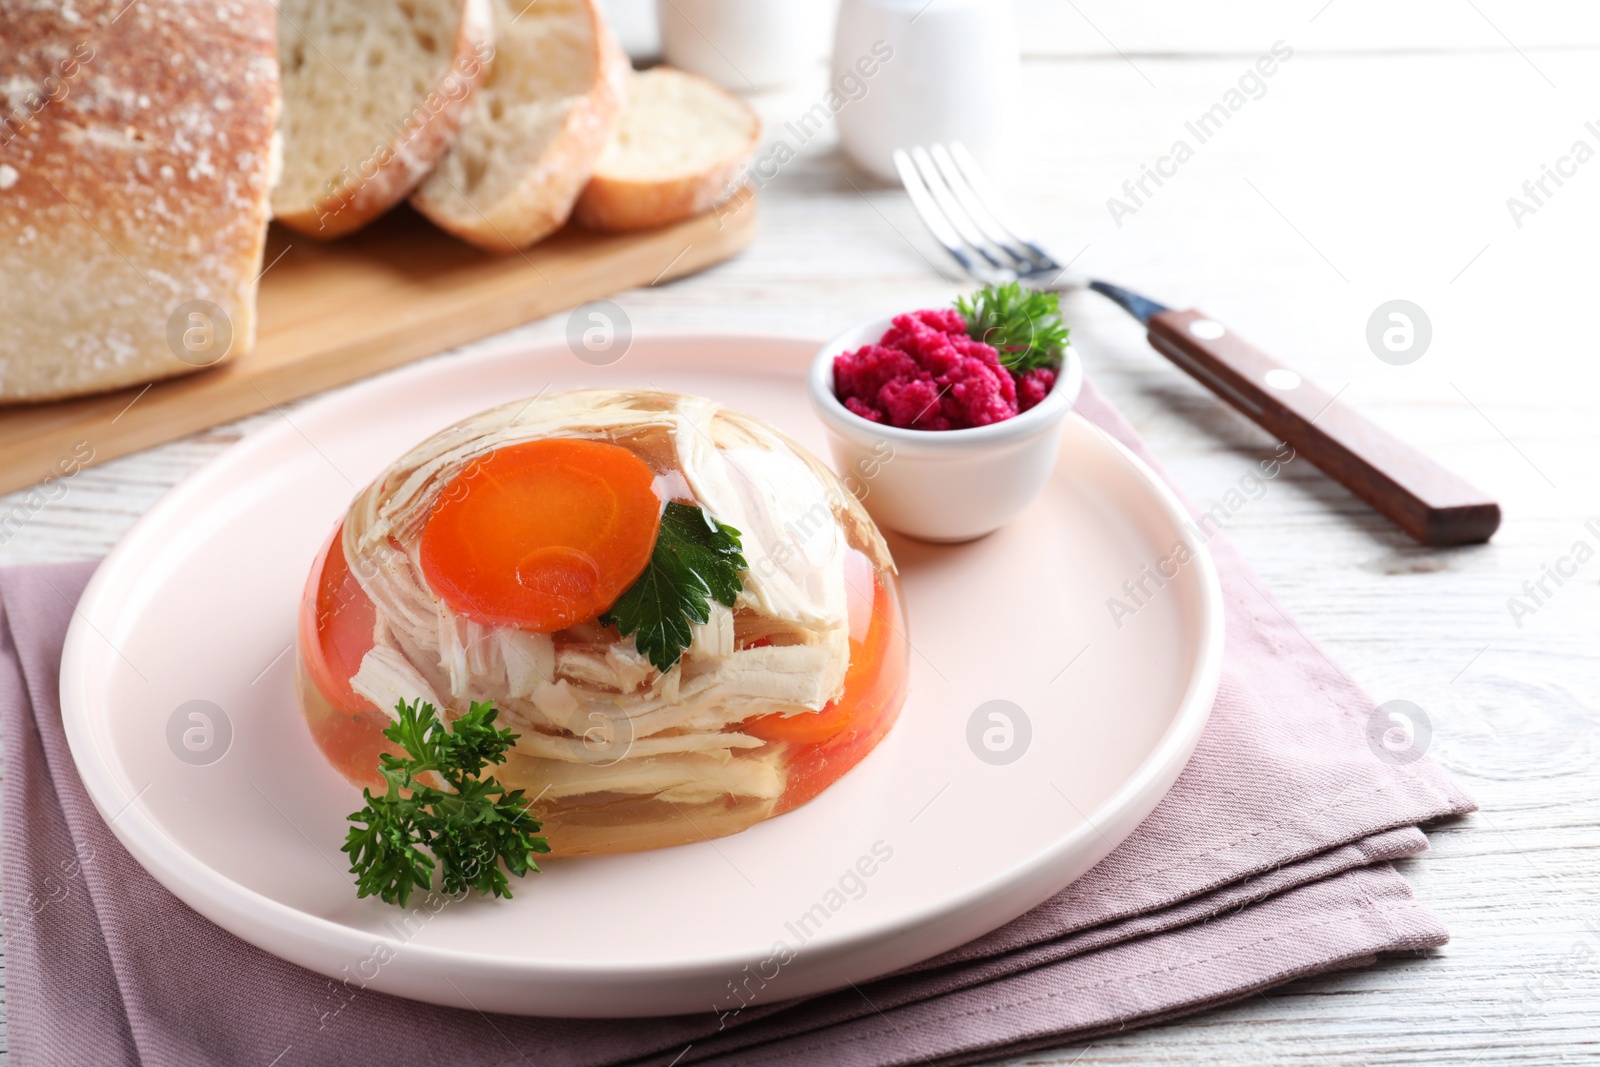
[421,438,661,633]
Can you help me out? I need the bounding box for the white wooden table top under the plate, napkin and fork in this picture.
[0,0,1600,1064]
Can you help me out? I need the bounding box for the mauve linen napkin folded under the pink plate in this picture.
[0,389,1474,1067]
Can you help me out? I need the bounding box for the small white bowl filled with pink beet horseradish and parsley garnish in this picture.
[806,283,1083,542]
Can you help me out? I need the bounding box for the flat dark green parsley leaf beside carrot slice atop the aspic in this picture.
[600,501,749,673]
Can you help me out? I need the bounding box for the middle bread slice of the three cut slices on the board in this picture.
[411,0,629,251]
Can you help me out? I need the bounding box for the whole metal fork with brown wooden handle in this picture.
[894,142,1501,545]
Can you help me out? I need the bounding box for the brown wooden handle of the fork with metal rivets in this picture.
[1149,310,1501,545]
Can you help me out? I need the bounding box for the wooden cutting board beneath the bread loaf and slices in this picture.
[0,194,757,493]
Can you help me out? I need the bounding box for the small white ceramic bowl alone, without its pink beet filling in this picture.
[808,318,1083,542]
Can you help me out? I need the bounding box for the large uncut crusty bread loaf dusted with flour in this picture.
[0,0,278,402]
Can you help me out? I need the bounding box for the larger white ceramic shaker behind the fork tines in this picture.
[834,0,1022,181]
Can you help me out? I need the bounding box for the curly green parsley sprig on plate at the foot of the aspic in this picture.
[342,701,550,907]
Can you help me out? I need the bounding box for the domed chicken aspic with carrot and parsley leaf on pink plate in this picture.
[299,389,907,856]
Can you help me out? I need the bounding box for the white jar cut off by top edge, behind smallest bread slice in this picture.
[658,0,838,93]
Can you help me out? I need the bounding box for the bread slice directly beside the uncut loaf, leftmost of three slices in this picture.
[272,0,493,237]
